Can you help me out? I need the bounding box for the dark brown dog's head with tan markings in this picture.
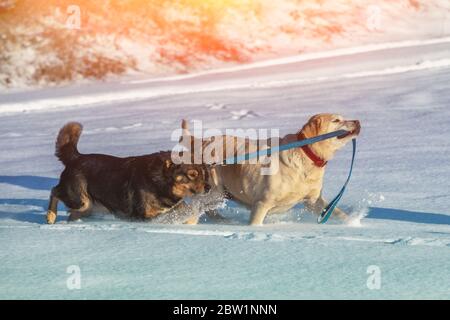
[164,160,210,198]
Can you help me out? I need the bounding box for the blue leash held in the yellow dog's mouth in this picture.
[222,130,356,224]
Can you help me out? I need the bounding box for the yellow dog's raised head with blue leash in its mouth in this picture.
[299,113,361,161]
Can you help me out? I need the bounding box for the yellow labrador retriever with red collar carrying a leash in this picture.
[181,114,361,225]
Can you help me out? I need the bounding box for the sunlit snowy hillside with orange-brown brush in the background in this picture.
[0,0,450,88]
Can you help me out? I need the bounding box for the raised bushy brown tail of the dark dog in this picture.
[55,122,83,166]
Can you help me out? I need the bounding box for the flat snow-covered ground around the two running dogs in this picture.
[0,39,450,299]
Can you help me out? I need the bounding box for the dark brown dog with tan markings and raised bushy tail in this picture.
[47,122,209,224]
